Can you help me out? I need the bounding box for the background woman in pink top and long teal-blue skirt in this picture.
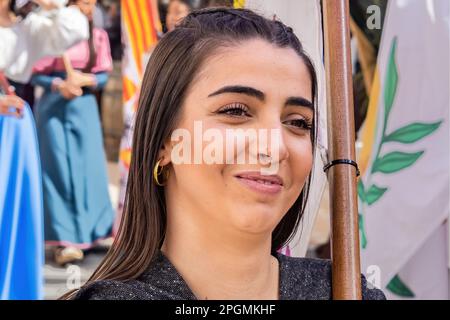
[31,0,113,265]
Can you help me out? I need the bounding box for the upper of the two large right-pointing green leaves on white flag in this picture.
[383,121,442,143]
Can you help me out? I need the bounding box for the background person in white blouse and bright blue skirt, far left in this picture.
[0,0,89,300]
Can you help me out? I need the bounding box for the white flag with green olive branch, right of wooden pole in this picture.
[358,0,450,299]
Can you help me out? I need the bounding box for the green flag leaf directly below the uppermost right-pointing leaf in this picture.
[372,151,424,173]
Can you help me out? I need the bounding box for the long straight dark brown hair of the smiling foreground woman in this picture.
[63,8,317,298]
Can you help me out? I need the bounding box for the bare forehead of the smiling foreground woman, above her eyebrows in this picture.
[191,40,312,99]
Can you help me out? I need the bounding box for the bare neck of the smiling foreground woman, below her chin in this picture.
[161,200,279,300]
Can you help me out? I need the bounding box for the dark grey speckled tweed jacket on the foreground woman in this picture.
[75,252,386,300]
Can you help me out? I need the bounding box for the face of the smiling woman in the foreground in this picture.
[160,40,314,235]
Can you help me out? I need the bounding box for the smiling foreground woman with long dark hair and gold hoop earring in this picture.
[66,8,384,299]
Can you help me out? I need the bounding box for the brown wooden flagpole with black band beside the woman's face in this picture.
[322,0,361,300]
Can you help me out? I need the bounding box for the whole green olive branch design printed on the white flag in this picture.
[357,37,443,297]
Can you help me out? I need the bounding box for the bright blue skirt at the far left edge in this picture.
[0,106,44,300]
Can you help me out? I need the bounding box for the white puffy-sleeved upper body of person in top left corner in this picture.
[0,0,88,107]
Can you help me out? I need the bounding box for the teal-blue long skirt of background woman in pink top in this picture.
[35,90,114,249]
